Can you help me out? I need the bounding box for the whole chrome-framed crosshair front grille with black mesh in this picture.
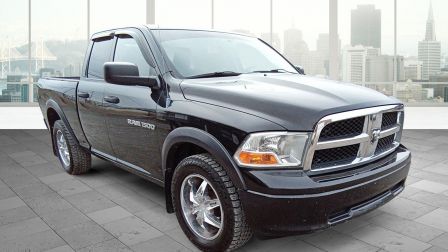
[304,105,403,174]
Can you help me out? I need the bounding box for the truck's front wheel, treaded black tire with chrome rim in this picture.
[171,154,252,251]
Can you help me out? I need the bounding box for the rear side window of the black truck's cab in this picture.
[87,39,113,79]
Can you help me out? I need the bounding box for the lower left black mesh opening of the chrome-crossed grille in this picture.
[313,144,359,168]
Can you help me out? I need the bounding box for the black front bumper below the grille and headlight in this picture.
[240,146,411,236]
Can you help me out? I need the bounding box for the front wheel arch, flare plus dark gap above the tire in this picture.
[162,127,246,213]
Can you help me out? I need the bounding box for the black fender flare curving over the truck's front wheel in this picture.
[162,127,247,212]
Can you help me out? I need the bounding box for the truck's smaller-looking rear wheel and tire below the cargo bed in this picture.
[53,120,91,175]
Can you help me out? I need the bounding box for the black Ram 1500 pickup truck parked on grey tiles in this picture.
[38,26,411,251]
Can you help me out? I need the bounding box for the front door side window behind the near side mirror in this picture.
[114,37,156,76]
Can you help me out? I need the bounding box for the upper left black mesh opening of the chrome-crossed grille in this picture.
[319,116,365,141]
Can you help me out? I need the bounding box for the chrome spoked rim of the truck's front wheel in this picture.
[180,174,224,240]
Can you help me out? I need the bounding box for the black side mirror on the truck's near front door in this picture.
[104,62,160,89]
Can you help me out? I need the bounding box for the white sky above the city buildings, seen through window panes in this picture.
[0,0,448,56]
